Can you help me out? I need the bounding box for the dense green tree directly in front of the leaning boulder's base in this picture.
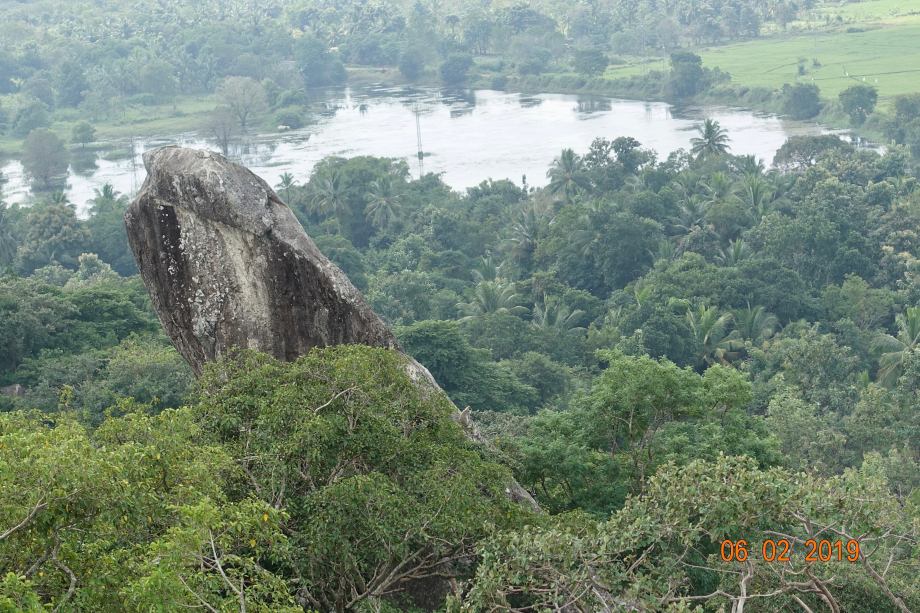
[196,346,527,610]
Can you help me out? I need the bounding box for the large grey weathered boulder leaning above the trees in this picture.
[125,146,536,508]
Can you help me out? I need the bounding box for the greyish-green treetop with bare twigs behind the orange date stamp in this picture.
[448,457,916,613]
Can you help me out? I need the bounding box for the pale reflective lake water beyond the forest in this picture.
[2,87,848,213]
